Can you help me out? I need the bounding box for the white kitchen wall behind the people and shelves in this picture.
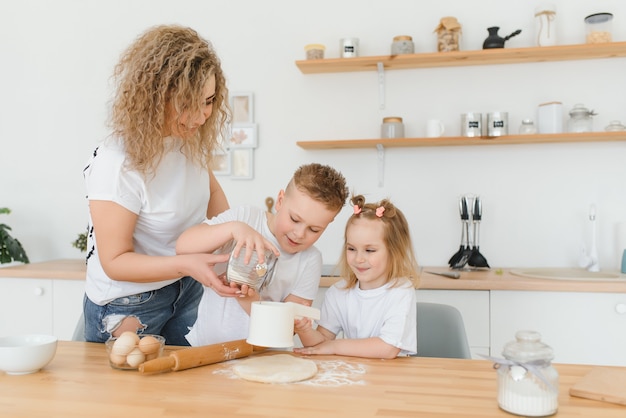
[0,0,626,269]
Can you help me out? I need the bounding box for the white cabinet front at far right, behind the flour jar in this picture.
[491,291,626,366]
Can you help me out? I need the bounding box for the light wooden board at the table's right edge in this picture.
[569,367,626,405]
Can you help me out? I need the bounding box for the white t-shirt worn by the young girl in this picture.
[318,279,417,356]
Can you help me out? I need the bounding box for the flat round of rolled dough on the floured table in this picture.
[233,354,317,383]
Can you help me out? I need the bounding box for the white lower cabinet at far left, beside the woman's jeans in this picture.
[0,277,85,340]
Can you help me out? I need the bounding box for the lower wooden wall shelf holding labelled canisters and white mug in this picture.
[296,132,626,149]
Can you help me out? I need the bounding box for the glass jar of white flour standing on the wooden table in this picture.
[498,331,559,417]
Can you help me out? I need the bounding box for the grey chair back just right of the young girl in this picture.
[417,302,472,359]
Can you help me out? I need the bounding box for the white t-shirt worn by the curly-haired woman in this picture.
[83,138,210,305]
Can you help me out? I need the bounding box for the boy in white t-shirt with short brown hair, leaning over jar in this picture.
[176,163,348,346]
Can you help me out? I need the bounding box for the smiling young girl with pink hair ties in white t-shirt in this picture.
[294,195,419,359]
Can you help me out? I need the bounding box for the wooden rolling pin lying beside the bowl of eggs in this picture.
[139,340,265,374]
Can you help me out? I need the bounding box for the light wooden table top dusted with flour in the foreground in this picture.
[0,341,626,418]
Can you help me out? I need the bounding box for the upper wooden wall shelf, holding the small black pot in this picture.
[296,42,626,74]
